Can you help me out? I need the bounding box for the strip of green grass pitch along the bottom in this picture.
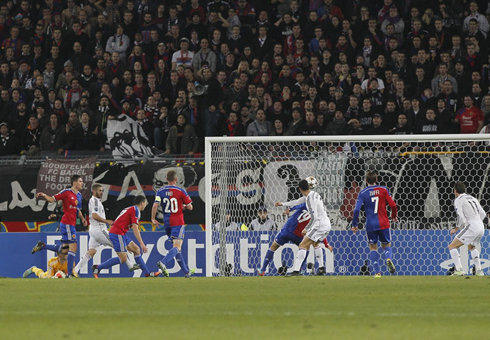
[0,276,490,340]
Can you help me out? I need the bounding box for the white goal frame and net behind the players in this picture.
[205,135,490,276]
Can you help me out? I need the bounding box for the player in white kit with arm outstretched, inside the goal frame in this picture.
[276,179,331,276]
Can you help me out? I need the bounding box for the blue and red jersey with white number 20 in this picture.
[153,185,192,227]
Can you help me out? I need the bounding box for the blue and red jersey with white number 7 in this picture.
[352,185,397,231]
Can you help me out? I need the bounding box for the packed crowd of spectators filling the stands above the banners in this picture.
[0,0,490,155]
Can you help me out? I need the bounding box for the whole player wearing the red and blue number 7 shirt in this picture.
[351,172,397,277]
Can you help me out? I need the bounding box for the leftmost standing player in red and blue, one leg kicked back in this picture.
[36,175,87,277]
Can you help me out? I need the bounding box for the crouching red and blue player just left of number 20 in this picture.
[92,195,161,279]
